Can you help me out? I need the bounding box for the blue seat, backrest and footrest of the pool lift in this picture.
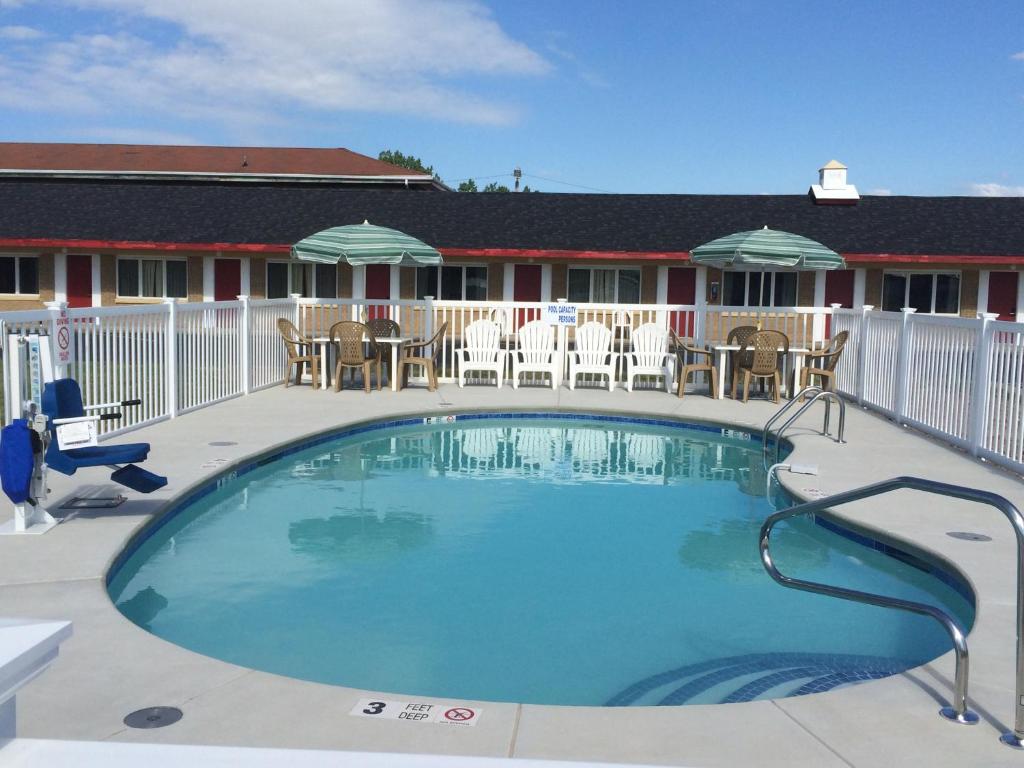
[43,379,167,494]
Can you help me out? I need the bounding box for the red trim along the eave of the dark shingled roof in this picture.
[0,238,1024,264]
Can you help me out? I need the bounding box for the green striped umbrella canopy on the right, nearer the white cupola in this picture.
[690,226,846,269]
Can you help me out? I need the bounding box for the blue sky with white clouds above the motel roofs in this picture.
[0,0,1024,196]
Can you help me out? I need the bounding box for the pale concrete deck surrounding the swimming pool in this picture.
[0,385,1024,767]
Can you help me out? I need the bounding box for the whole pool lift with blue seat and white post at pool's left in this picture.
[0,379,167,532]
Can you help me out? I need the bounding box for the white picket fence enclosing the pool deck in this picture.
[0,297,1024,472]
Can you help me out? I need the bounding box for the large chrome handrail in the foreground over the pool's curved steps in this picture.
[760,477,1024,749]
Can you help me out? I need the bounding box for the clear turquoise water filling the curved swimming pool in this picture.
[110,418,973,706]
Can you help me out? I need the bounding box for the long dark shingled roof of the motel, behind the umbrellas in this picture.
[0,180,1024,256]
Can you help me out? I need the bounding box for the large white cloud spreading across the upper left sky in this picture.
[0,0,550,125]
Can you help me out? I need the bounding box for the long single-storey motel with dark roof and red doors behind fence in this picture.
[0,143,1024,322]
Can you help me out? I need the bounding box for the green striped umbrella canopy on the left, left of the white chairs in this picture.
[292,221,441,266]
